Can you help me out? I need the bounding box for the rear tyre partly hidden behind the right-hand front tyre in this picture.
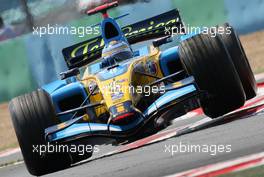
[218,23,257,100]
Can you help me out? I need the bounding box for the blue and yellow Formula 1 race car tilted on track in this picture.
[9,2,257,175]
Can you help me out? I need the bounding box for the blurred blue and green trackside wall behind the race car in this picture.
[0,0,264,103]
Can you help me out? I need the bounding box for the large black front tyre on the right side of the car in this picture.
[179,34,245,118]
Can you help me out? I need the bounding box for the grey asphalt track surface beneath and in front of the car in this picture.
[0,88,264,177]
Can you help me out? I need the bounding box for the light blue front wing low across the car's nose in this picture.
[45,77,199,142]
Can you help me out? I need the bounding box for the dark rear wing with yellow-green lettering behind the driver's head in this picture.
[62,9,184,69]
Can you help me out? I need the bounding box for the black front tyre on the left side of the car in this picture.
[9,90,71,176]
